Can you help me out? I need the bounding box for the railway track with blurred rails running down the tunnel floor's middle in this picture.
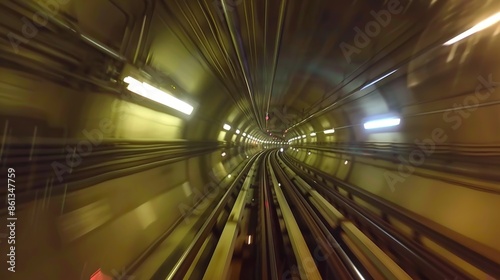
[124,150,496,280]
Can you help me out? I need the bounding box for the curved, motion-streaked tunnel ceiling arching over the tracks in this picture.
[5,0,498,142]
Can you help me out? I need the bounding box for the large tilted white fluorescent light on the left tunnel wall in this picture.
[123,77,193,115]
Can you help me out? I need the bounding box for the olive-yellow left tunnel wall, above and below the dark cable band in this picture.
[0,66,256,279]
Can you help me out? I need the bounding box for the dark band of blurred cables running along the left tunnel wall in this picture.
[0,141,224,208]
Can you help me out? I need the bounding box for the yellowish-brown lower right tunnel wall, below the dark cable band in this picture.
[287,147,500,260]
